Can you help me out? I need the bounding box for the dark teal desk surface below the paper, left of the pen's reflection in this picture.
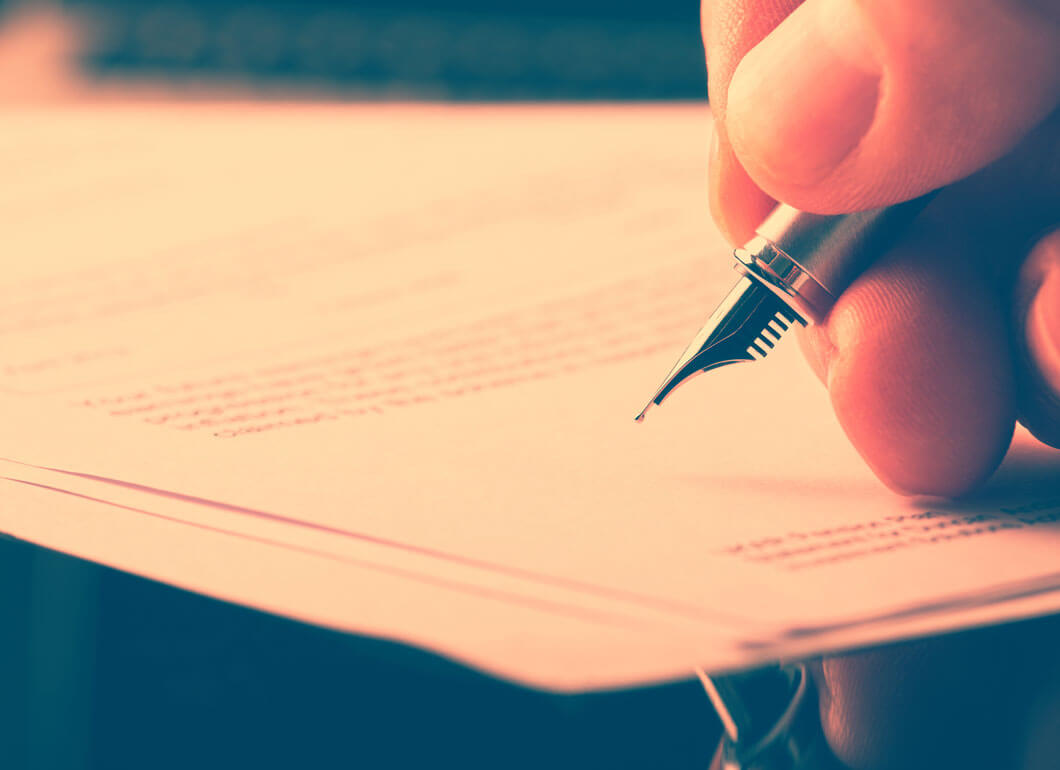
[0,539,719,770]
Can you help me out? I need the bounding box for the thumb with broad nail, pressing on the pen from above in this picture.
[725,0,1060,213]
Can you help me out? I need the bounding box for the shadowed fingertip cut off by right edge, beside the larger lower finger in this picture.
[1015,230,1060,448]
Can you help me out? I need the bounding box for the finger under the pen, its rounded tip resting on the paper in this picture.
[802,198,1015,495]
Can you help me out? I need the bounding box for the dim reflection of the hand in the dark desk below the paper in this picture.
[814,616,1060,770]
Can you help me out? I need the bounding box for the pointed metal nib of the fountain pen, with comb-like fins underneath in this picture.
[636,276,806,422]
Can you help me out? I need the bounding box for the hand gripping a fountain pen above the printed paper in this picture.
[703,0,1060,495]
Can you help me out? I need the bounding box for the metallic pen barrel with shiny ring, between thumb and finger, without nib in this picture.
[736,194,933,321]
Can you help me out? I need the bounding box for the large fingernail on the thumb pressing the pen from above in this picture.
[725,0,881,186]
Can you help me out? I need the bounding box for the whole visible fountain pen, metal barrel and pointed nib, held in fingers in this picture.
[636,194,933,422]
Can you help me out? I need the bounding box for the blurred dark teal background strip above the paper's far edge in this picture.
[0,0,706,101]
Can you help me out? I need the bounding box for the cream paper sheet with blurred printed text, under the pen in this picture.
[0,106,1060,689]
